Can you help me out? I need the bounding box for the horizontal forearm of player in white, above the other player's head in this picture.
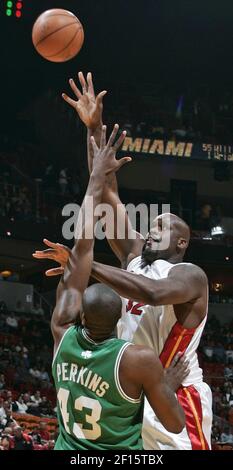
[91,262,155,305]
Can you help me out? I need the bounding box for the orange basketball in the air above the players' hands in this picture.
[32,8,84,62]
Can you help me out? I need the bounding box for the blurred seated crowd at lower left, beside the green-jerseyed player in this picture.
[0,302,57,450]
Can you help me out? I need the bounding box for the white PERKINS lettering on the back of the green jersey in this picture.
[56,362,109,397]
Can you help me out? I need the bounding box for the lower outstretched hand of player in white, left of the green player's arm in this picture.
[32,238,71,276]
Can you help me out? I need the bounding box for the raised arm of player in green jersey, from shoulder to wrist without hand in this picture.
[51,165,105,349]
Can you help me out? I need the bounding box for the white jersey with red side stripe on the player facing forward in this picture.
[118,256,207,387]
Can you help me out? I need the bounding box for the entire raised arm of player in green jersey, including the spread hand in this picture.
[51,127,129,344]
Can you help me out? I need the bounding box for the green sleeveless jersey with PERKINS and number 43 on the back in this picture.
[53,326,143,450]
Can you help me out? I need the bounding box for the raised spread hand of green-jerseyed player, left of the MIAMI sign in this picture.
[91,124,132,175]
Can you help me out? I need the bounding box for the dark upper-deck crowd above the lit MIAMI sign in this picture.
[106,84,233,144]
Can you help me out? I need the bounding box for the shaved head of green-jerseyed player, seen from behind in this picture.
[82,284,122,339]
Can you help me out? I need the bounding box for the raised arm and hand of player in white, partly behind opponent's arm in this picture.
[62,72,144,268]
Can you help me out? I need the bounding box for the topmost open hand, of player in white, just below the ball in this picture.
[62,72,107,131]
